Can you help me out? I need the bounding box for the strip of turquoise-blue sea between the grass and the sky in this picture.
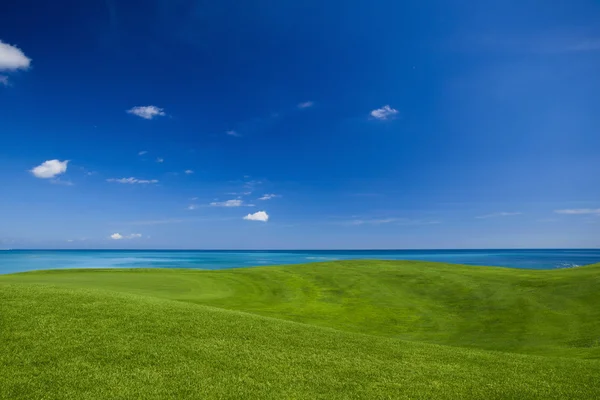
[0,249,600,274]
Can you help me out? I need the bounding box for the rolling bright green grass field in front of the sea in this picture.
[0,261,600,399]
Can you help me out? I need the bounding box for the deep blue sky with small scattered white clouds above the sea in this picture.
[0,0,600,249]
